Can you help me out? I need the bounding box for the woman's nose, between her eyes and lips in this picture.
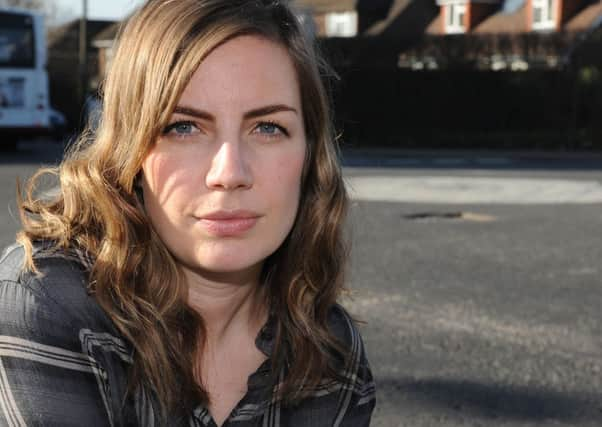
[206,142,253,191]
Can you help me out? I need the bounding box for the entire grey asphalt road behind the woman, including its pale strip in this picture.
[0,144,602,427]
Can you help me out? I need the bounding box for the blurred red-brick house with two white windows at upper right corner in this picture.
[398,0,602,71]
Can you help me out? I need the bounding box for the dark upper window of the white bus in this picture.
[0,12,35,68]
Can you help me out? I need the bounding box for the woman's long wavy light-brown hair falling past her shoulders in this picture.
[18,0,348,422]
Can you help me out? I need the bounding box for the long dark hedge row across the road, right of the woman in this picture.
[334,67,602,148]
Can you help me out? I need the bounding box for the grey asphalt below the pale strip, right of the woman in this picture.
[348,203,602,426]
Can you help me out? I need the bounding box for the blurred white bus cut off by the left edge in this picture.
[0,8,50,148]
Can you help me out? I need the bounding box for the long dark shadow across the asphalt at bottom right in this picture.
[377,379,602,425]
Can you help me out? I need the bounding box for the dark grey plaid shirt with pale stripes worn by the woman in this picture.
[0,245,375,427]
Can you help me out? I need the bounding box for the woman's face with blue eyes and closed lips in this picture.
[142,36,306,275]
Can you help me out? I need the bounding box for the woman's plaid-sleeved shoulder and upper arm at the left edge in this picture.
[0,246,131,425]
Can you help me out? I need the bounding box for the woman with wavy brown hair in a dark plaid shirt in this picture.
[0,0,374,426]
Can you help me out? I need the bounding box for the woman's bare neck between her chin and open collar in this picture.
[186,271,267,348]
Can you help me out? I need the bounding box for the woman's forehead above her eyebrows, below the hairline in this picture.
[180,36,300,112]
